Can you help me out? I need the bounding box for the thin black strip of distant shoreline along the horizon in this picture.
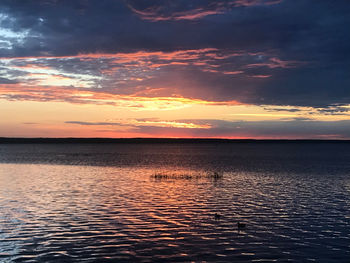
[0,137,350,144]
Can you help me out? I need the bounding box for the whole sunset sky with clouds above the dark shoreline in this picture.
[0,0,350,139]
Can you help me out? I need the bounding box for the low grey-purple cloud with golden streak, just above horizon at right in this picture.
[66,118,350,139]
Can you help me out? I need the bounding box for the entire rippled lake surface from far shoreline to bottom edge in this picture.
[0,143,350,262]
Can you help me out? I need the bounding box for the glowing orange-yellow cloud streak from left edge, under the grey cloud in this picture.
[0,84,240,110]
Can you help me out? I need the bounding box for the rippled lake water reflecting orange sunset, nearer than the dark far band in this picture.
[0,143,350,262]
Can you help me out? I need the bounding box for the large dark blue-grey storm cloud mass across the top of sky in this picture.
[0,0,350,107]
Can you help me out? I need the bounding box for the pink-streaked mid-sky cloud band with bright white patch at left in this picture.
[0,48,300,104]
